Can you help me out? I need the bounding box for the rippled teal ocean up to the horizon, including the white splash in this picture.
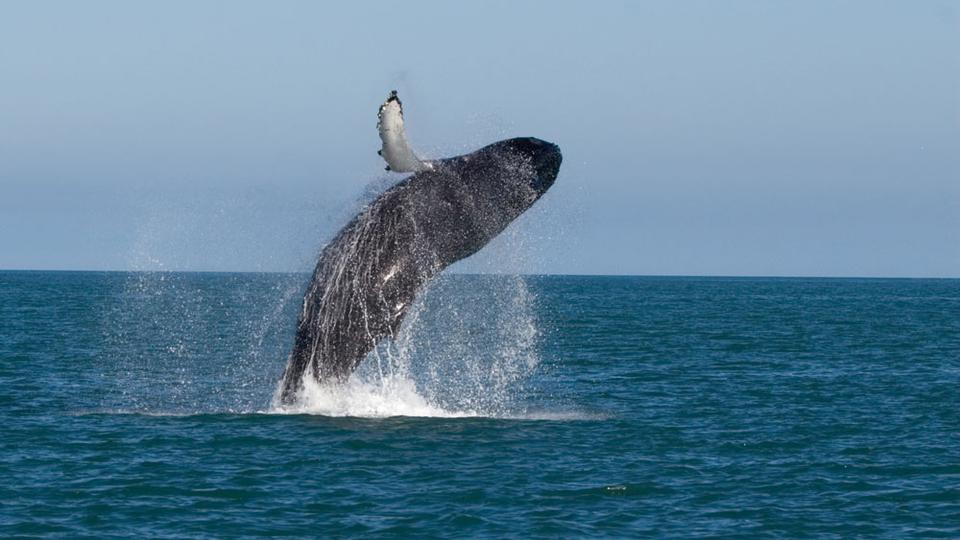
[0,272,960,538]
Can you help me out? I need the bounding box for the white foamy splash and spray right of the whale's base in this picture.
[274,274,540,417]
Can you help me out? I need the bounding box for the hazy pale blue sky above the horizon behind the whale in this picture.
[0,0,960,277]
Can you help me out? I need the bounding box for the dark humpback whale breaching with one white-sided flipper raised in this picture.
[278,92,562,405]
